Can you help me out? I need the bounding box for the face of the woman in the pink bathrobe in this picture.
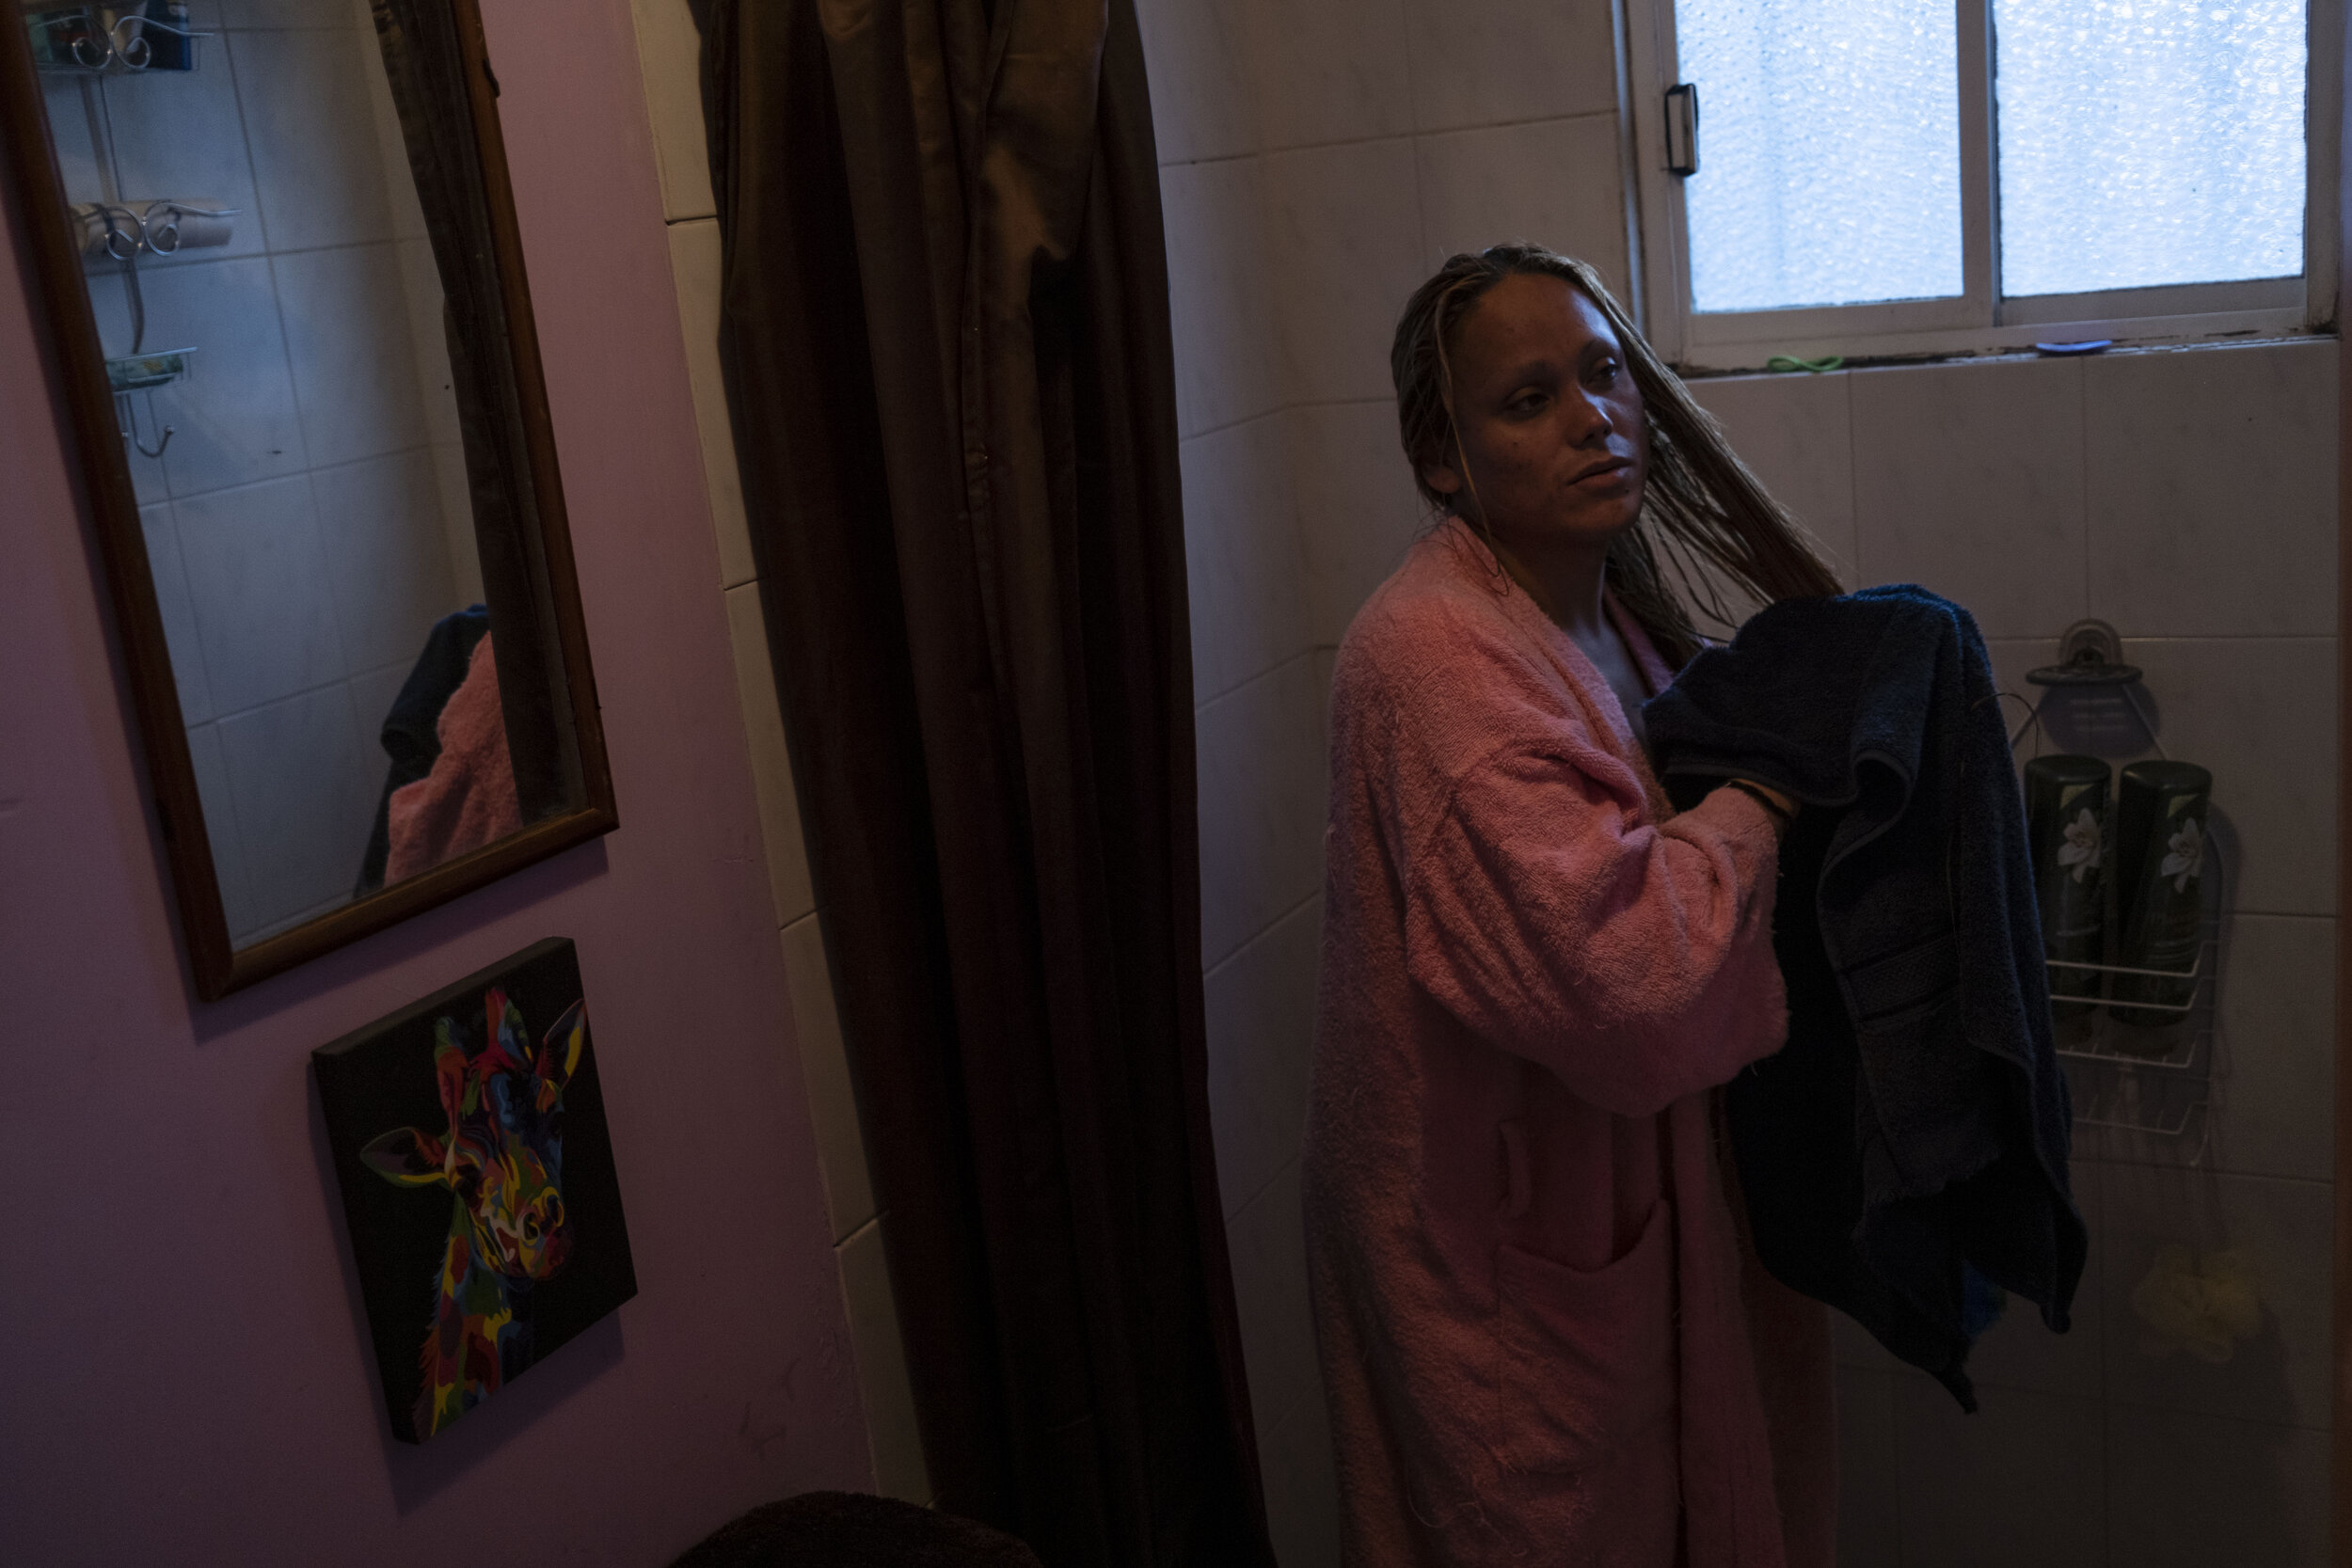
[1423,273,1649,550]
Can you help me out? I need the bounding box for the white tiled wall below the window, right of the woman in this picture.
[1693,341,2338,1568]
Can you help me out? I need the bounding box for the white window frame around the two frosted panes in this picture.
[1623,0,2345,372]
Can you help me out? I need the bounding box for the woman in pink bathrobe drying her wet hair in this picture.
[1306,246,1837,1568]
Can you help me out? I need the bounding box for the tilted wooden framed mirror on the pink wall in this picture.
[0,0,616,999]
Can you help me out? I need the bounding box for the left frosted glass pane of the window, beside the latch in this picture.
[1675,0,1962,310]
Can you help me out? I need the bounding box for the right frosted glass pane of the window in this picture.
[1993,0,2303,293]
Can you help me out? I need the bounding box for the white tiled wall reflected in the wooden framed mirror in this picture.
[45,0,480,942]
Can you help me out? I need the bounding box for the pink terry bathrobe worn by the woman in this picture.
[1306,522,1835,1568]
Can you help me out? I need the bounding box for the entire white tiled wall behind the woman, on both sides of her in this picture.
[1143,0,2338,1568]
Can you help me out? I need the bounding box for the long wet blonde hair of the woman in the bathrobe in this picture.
[1388,245,1839,668]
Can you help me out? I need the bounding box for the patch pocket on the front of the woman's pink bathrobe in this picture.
[1494,1199,1675,1474]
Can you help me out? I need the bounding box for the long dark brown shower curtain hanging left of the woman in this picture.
[706,0,1273,1568]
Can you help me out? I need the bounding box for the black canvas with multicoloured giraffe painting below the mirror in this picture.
[310,938,638,1444]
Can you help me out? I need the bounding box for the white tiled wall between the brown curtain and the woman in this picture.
[1138,0,1656,1568]
